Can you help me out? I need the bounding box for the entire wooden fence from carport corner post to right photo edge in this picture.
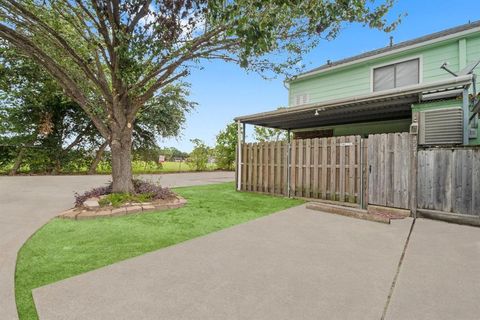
[237,133,480,216]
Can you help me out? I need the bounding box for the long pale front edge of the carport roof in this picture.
[234,74,473,122]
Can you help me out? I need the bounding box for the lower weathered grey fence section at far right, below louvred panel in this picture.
[417,147,480,216]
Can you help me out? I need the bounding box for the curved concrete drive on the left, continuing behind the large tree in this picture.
[0,172,234,320]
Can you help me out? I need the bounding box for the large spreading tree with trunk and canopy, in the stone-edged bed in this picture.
[0,0,398,192]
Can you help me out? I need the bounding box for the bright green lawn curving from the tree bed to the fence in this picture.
[15,183,302,320]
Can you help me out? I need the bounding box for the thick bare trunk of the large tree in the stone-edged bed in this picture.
[110,128,134,193]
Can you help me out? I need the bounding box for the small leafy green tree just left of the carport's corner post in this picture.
[215,122,237,170]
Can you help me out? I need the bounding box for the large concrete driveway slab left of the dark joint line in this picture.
[33,206,412,320]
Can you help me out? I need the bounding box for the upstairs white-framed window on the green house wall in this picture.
[373,59,420,91]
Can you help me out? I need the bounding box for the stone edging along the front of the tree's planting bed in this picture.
[58,196,187,220]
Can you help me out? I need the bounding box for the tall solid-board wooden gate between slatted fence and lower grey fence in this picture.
[367,133,411,209]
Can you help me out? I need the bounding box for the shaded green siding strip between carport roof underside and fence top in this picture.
[294,119,411,137]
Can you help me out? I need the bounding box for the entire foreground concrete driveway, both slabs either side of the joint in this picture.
[33,206,480,320]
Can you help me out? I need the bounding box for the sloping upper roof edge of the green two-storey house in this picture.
[285,21,480,82]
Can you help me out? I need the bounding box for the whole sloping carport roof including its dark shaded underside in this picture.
[235,75,473,130]
